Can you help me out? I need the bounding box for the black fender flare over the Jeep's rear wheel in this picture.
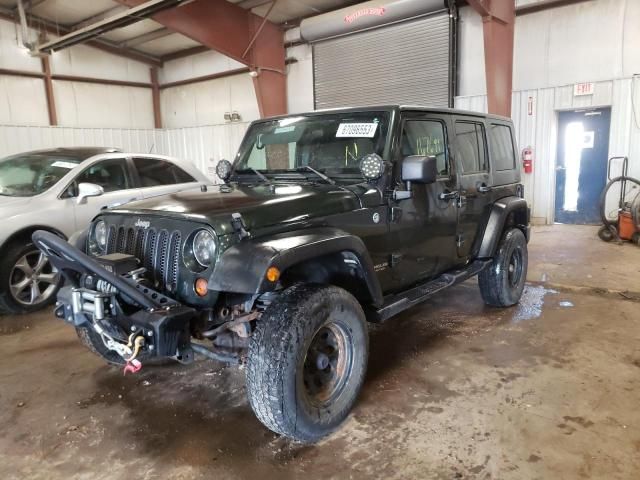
[478,196,530,259]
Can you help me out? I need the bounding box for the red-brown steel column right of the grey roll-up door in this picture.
[467,0,516,117]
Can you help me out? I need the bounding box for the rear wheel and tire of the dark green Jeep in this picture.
[478,228,529,307]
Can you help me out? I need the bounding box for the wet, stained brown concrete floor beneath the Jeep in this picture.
[0,226,640,480]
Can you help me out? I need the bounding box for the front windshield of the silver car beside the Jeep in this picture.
[0,153,82,197]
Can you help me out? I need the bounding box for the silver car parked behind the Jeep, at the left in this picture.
[0,148,210,313]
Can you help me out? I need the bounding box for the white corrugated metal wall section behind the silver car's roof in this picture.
[0,123,248,180]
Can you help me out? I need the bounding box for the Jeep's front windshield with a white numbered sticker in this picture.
[234,112,390,182]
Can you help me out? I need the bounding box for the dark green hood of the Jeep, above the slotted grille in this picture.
[109,184,361,235]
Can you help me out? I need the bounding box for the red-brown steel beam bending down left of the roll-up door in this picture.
[117,0,287,117]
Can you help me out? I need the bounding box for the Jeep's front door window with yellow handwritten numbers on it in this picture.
[402,120,449,176]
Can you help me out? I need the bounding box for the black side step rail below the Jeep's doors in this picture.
[369,260,491,323]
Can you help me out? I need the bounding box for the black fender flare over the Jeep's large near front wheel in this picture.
[209,228,383,305]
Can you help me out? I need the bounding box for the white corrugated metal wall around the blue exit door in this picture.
[456,77,640,223]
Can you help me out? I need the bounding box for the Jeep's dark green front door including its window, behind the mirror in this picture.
[390,112,457,288]
